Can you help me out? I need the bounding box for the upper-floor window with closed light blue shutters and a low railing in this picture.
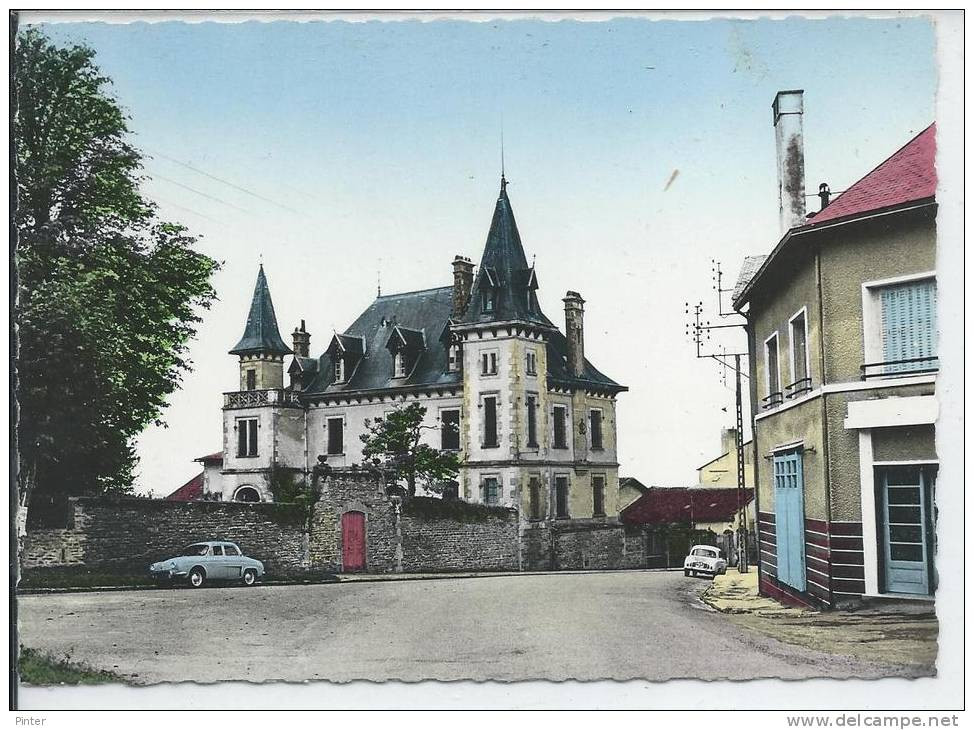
[879,279,937,373]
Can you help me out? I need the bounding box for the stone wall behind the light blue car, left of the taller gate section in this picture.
[21,497,308,576]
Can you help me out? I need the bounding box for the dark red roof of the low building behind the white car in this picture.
[619,487,754,525]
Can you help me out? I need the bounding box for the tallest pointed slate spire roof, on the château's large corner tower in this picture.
[460,176,554,327]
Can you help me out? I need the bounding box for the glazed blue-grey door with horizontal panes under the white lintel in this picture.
[881,467,933,595]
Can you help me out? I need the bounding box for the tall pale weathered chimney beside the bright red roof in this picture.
[771,89,805,235]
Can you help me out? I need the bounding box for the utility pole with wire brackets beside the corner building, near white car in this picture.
[684,260,748,573]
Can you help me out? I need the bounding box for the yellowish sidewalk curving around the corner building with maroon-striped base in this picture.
[702,568,938,675]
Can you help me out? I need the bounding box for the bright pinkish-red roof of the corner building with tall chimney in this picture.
[808,122,937,226]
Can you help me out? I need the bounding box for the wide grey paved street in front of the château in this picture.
[20,572,928,684]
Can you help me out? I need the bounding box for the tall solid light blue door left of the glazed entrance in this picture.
[774,450,805,591]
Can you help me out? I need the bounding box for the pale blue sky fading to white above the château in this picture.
[28,17,937,494]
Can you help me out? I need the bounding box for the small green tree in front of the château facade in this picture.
[359,403,460,497]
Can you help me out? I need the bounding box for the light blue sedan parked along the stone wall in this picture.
[149,540,264,588]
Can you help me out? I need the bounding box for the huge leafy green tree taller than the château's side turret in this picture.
[13,29,218,520]
